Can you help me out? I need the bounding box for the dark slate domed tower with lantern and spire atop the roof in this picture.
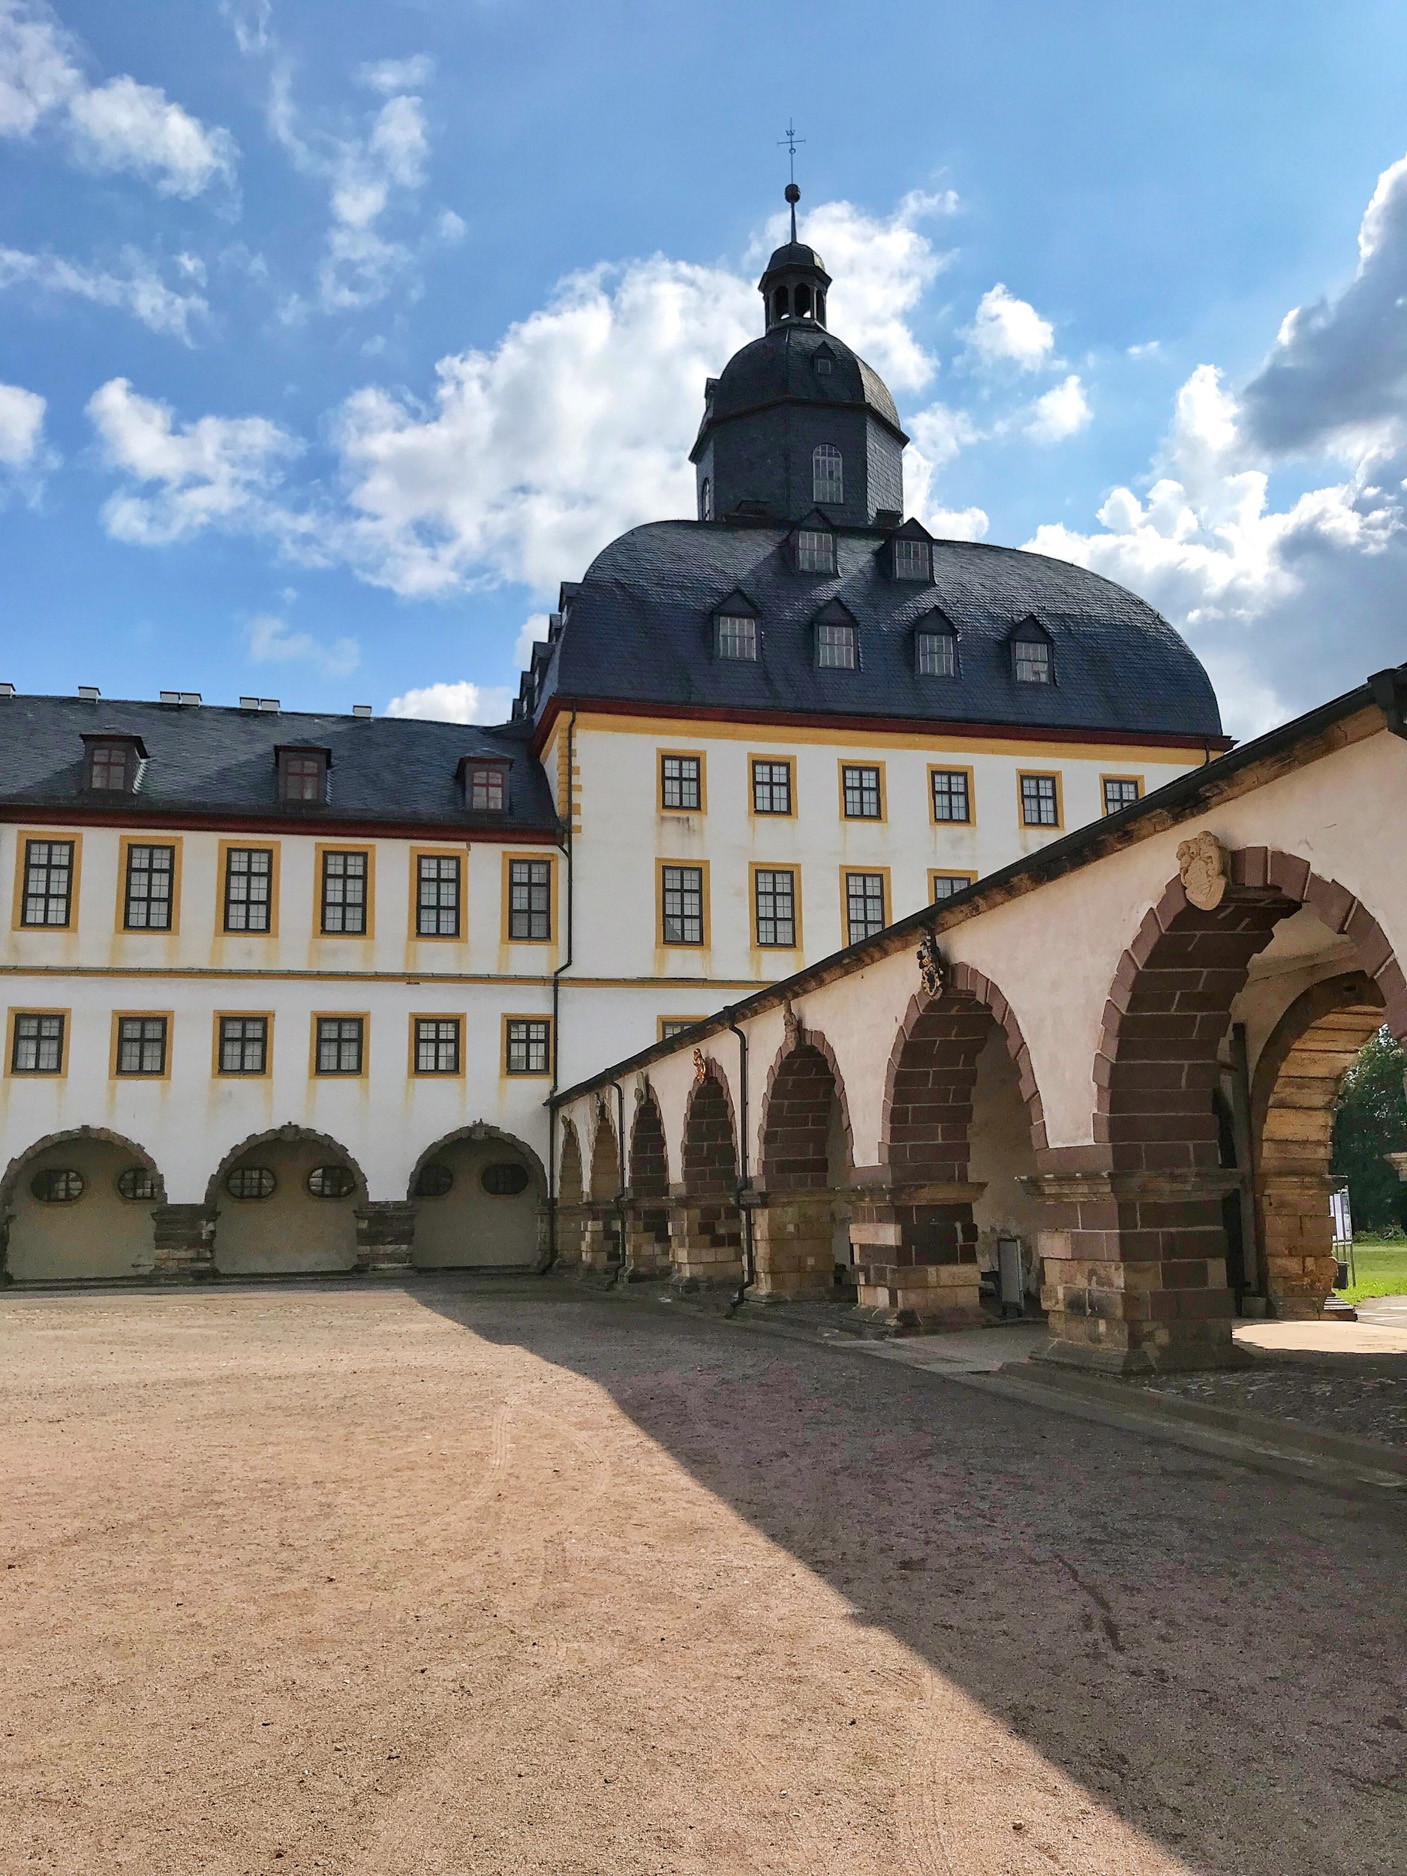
[690,184,908,527]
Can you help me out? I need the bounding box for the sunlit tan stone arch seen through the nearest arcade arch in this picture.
[1251,970,1383,1317]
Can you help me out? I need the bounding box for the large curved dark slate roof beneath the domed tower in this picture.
[537,522,1221,737]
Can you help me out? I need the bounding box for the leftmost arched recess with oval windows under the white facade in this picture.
[0,1127,165,1283]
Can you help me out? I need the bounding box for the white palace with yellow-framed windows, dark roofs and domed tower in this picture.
[0,197,1229,1281]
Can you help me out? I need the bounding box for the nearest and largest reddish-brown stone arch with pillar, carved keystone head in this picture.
[1052,848,1407,1369]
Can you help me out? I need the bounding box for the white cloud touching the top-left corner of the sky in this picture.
[0,0,238,199]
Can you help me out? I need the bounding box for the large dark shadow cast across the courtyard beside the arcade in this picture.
[416,1279,1407,1876]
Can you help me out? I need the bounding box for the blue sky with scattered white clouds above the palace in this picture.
[0,0,1407,735]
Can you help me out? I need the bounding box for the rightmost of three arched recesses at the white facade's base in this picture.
[407,1122,548,1270]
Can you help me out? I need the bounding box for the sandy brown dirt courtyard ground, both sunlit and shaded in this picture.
[0,1279,1407,1876]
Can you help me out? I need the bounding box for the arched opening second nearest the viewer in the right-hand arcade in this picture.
[880,964,1047,1309]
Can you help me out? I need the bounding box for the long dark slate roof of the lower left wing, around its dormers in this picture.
[0,696,557,835]
